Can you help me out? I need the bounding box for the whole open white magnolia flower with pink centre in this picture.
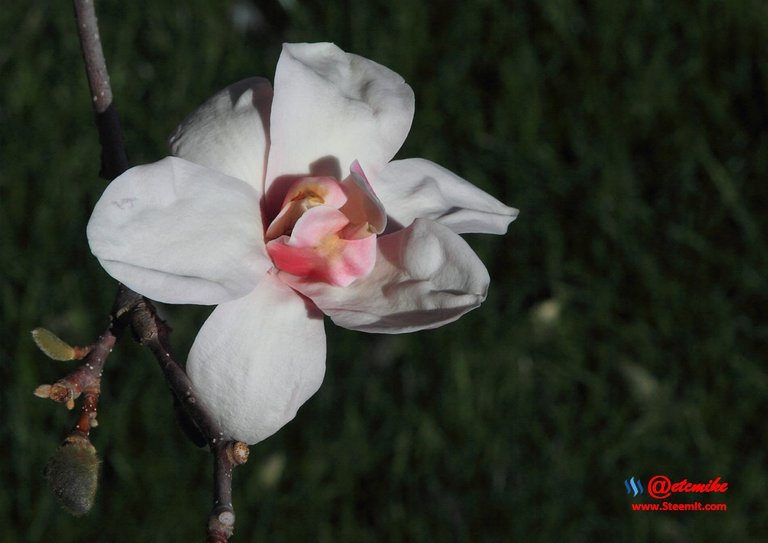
[88,43,517,444]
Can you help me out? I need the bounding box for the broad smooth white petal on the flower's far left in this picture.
[87,157,271,304]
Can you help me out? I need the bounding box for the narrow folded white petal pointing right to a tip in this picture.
[373,158,517,234]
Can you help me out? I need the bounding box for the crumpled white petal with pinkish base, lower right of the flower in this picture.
[280,219,489,334]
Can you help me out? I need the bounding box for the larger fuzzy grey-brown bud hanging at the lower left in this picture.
[43,433,99,517]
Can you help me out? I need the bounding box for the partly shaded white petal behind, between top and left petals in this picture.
[170,77,272,194]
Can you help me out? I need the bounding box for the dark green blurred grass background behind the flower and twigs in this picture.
[0,0,768,542]
